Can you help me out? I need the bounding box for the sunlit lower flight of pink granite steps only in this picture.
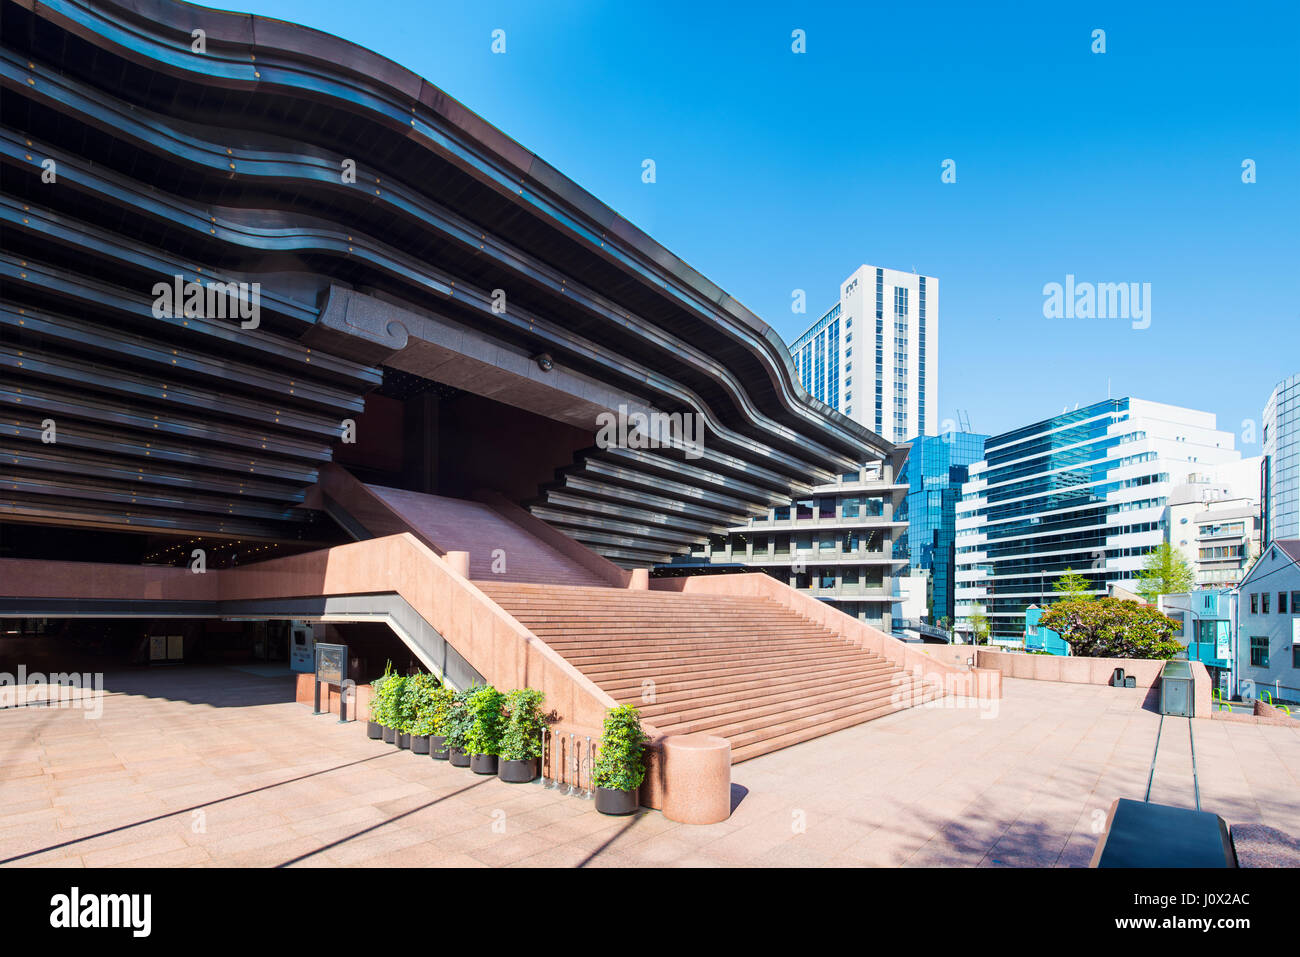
[475,580,937,761]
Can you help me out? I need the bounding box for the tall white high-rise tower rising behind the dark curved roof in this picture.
[790,265,939,442]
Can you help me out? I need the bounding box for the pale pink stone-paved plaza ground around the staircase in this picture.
[0,668,1300,867]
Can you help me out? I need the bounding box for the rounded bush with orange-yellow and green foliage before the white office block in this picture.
[1039,598,1183,658]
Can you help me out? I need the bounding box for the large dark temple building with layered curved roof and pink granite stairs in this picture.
[0,0,982,806]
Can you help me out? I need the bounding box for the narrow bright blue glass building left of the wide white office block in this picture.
[894,432,988,624]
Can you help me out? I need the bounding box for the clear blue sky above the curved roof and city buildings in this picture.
[251,0,1300,442]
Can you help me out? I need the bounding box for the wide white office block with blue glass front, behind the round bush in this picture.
[956,398,1240,645]
